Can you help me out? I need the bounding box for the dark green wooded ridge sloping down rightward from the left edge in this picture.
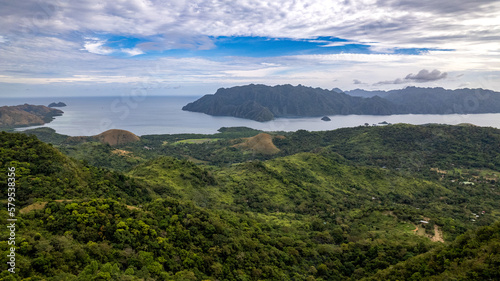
[0,132,150,207]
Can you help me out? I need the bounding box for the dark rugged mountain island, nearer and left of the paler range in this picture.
[182,84,395,122]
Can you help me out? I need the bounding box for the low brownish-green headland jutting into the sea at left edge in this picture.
[0,104,63,128]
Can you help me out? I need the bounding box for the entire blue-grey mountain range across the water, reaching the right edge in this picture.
[182,84,500,121]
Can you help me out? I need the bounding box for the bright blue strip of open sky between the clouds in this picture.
[90,36,452,59]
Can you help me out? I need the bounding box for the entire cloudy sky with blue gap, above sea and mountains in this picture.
[0,0,500,98]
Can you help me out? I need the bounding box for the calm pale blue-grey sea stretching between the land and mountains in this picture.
[0,96,500,136]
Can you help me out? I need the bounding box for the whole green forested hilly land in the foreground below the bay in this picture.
[0,124,500,280]
